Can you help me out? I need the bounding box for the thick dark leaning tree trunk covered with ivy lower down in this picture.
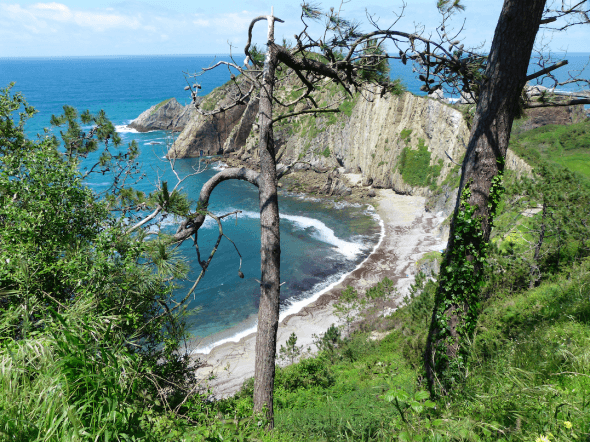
[425,0,545,392]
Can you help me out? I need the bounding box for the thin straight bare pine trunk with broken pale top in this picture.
[254,16,281,428]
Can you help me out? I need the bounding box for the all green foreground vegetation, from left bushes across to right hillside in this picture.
[0,83,590,442]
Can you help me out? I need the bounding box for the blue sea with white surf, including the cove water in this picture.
[0,54,588,351]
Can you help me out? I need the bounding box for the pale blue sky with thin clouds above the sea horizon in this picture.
[0,0,590,57]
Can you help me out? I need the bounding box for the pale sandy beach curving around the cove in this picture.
[193,180,446,397]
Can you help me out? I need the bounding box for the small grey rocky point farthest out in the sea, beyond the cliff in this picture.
[128,98,196,132]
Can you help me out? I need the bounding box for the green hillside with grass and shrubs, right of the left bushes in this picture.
[164,117,590,442]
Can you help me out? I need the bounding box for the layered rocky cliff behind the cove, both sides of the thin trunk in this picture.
[168,82,531,196]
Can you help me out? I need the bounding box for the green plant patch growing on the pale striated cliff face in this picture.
[397,138,443,187]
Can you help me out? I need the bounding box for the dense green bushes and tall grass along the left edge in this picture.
[0,84,192,441]
